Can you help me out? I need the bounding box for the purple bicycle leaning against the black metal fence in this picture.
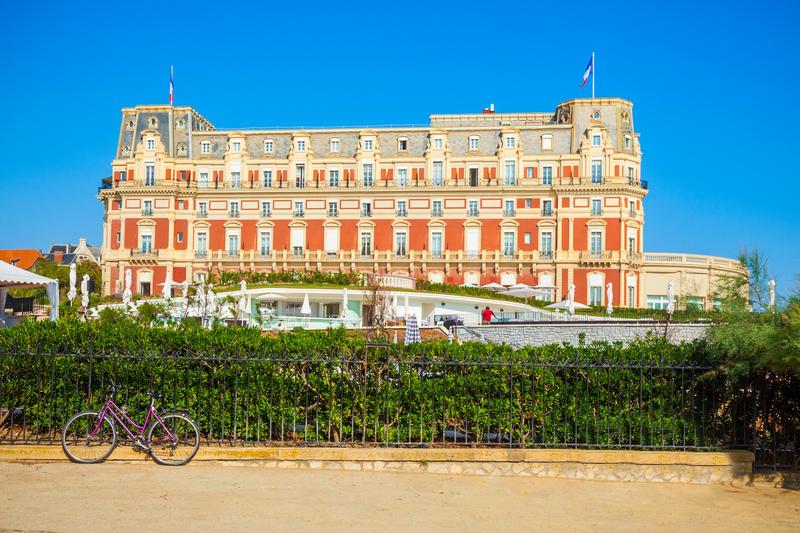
[61,383,200,466]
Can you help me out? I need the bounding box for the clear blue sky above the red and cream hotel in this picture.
[0,1,800,292]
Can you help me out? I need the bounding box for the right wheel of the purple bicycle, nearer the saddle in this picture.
[147,413,200,466]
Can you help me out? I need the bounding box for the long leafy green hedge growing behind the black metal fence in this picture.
[0,319,728,448]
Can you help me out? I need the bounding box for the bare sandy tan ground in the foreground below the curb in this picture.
[0,463,800,533]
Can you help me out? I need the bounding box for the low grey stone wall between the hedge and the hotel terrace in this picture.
[458,321,708,348]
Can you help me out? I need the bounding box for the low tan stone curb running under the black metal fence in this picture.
[0,445,754,483]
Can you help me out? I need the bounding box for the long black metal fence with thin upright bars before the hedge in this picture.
[0,353,800,468]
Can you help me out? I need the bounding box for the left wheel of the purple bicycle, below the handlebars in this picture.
[61,411,117,464]
